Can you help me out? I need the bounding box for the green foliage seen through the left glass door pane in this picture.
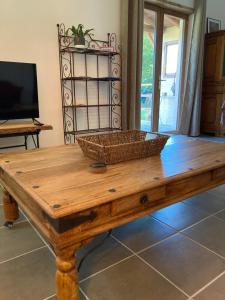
[141,32,154,94]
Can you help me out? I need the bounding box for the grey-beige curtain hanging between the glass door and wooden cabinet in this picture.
[179,0,206,136]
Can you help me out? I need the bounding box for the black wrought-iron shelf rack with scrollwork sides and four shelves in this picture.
[57,24,122,144]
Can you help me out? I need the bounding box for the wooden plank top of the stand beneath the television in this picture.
[0,122,53,135]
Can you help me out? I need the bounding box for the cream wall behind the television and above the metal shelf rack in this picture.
[0,0,120,146]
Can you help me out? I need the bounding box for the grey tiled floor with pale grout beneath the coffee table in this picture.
[0,137,225,300]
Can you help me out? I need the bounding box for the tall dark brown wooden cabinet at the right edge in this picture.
[201,30,225,136]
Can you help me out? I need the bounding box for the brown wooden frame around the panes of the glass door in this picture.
[144,1,189,133]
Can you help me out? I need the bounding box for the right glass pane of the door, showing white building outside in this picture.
[158,14,184,132]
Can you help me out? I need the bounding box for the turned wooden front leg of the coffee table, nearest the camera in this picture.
[56,250,80,300]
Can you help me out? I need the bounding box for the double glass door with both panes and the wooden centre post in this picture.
[140,4,187,132]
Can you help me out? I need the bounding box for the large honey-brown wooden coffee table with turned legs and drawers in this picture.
[0,139,225,300]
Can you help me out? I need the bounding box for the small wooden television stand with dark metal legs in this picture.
[0,122,53,149]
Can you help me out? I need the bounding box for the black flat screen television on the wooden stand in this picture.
[0,61,39,120]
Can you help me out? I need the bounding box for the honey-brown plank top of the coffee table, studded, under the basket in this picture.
[0,139,225,218]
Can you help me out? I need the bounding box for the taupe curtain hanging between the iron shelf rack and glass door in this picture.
[121,0,144,129]
